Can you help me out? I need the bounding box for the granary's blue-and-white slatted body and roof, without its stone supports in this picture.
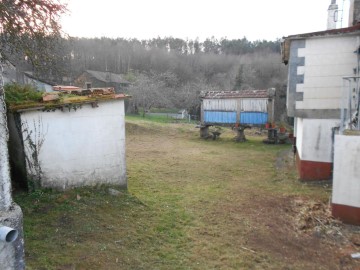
[201,88,275,126]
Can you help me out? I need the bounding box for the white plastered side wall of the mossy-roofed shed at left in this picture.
[21,100,126,189]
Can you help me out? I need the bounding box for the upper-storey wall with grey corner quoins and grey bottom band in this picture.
[287,36,360,119]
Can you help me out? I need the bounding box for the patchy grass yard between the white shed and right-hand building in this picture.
[15,121,336,269]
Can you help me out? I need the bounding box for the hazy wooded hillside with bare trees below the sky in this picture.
[9,37,286,115]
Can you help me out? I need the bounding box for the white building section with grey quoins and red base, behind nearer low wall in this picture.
[282,17,360,180]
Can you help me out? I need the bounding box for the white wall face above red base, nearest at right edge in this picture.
[332,135,360,207]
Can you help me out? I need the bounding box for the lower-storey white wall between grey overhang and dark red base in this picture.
[296,118,340,162]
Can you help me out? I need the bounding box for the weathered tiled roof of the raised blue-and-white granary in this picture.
[201,90,269,99]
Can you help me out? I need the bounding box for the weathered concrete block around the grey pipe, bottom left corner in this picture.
[0,204,25,270]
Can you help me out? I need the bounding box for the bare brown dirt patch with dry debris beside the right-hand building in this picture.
[206,188,360,269]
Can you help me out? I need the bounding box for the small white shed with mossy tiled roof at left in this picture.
[8,89,127,189]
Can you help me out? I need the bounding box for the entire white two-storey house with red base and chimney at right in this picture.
[282,0,360,225]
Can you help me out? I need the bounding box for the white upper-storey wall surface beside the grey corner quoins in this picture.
[296,36,360,109]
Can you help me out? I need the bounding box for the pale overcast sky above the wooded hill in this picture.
[62,0,350,41]
